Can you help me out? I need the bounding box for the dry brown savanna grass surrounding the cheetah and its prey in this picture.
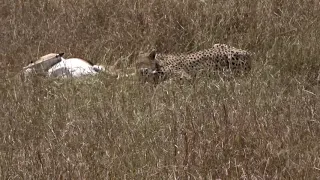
[0,0,320,179]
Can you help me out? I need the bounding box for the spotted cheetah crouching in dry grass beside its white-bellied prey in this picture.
[136,44,251,83]
